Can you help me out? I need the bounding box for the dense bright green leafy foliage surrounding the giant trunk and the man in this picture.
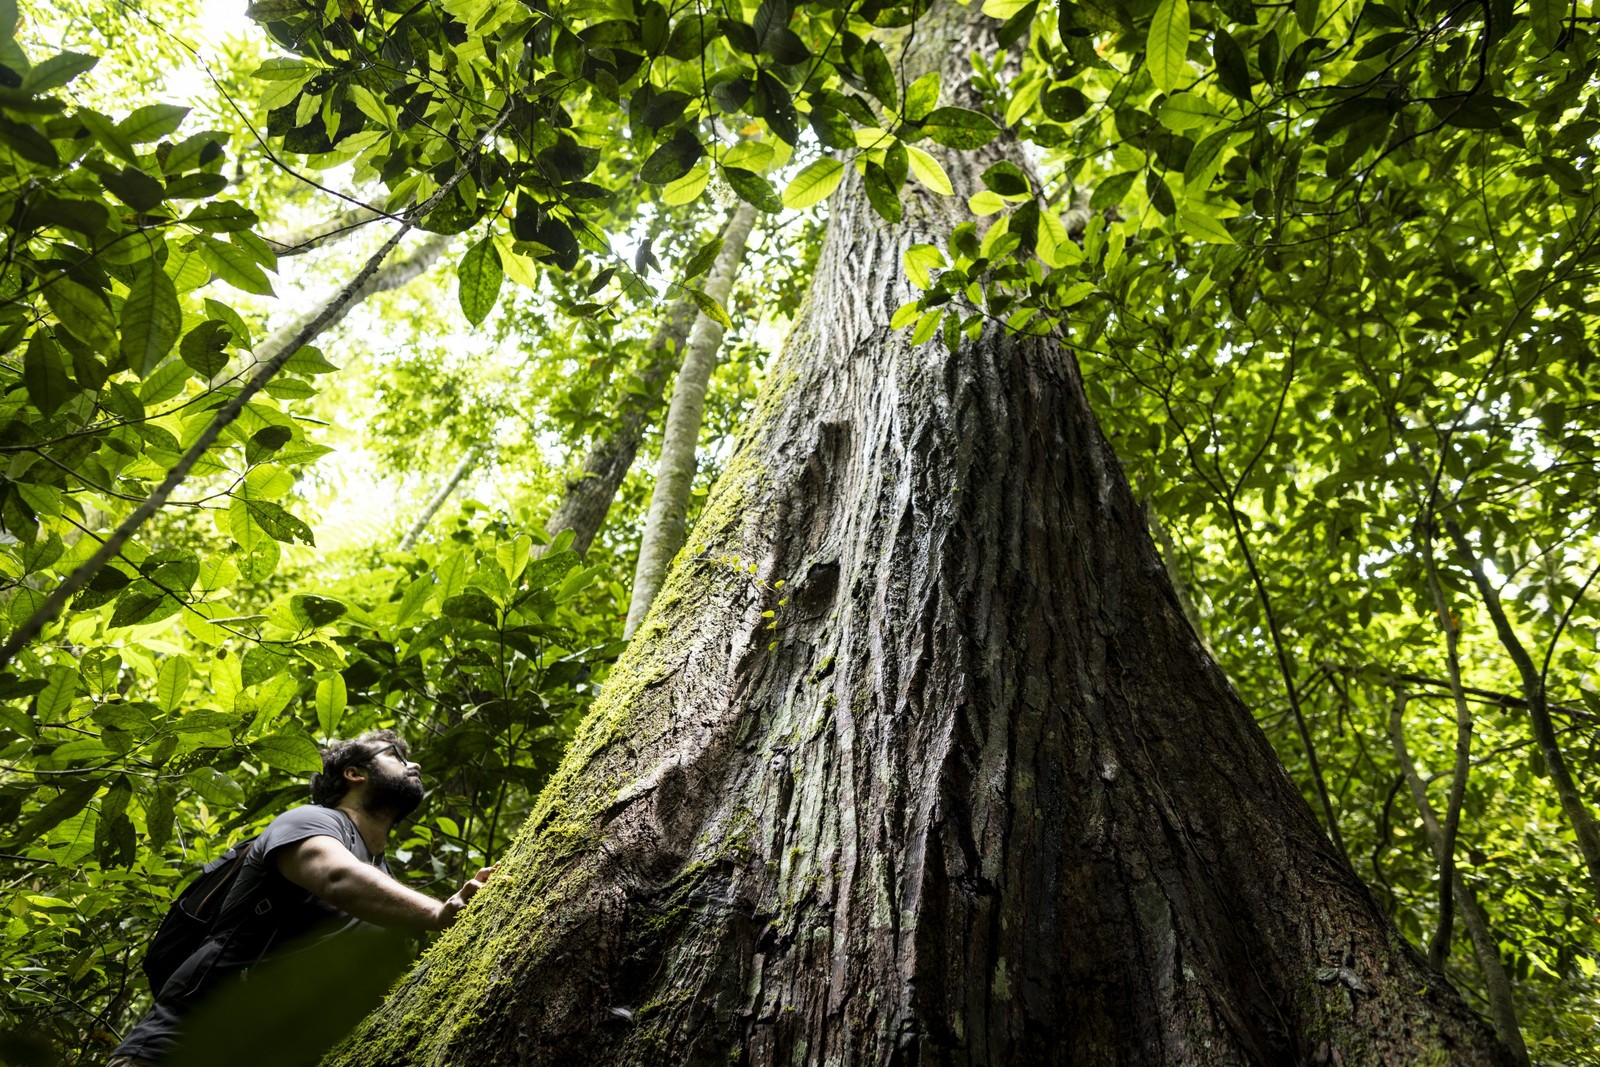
[0,0,1600,1064]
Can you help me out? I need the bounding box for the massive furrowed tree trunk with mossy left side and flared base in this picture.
[331,5,1506,1067]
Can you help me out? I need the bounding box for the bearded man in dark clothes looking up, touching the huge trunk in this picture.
[109,729,494,1067]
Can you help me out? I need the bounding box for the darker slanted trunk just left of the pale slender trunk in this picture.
[546,209,748,555]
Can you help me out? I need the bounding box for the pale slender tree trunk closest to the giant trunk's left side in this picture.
[622,203,755,637]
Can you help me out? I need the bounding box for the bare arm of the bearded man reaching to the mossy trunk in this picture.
[274,835,494,929]
